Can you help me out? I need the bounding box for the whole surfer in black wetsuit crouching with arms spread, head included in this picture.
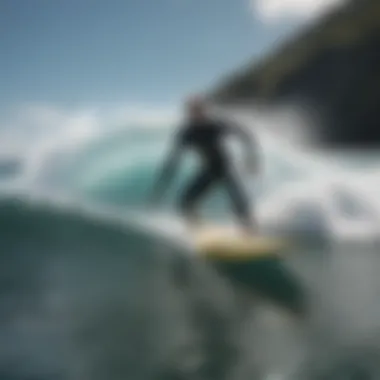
[151,97,258,233]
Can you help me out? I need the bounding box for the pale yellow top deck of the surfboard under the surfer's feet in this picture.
[194,226,290,261]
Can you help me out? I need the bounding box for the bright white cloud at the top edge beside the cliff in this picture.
[250,0,347,23]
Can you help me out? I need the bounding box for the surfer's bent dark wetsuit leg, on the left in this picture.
[179,168,221,223]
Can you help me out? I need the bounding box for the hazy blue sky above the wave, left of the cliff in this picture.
[0,0,306,113]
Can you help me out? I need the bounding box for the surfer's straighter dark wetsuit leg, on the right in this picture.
[225,171,257,231]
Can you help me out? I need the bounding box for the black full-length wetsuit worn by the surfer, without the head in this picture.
[153,119,256,227]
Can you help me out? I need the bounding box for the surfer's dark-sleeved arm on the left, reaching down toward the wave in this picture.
[152,129,186,203]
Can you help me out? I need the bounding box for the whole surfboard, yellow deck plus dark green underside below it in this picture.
[193,225,305,315]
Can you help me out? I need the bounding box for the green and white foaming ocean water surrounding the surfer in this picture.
[0,107,380,380]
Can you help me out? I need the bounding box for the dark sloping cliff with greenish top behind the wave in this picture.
[213,0,380,147]
